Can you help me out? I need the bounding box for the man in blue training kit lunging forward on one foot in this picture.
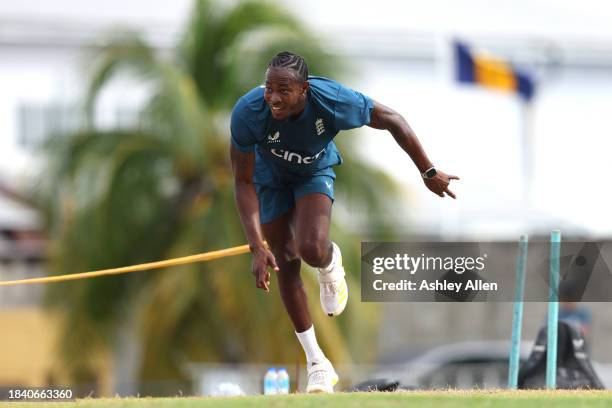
[230,51,459,392]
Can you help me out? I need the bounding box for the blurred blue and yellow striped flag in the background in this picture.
[455,42,535,101]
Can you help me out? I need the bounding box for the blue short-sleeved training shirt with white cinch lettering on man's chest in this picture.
[231,76,374,187]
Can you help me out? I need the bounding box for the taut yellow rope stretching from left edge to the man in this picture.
[0,245,250,286]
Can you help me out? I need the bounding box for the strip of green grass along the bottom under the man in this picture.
[0,391,612,408]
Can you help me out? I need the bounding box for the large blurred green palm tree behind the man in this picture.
[40,0,402,393]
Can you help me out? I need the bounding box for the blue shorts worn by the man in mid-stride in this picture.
[255,176,334,224]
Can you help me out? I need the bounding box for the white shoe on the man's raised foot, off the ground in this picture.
[317,242,348,316]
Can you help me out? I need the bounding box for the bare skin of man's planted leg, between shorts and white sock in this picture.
[261,210,312,333]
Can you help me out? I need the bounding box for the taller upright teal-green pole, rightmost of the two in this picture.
[546,230,561,390]
